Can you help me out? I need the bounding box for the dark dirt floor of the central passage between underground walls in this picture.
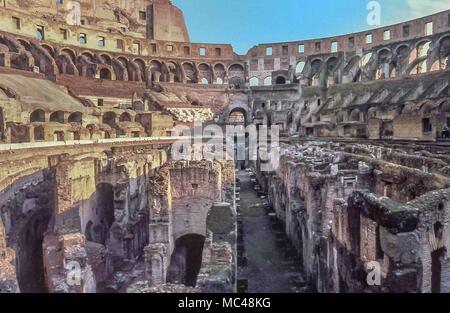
[238,171,302,293]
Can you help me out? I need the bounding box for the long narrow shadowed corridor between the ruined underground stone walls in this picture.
[237,171,305,293]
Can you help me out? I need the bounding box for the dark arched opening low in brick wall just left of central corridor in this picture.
[168,234,205,287]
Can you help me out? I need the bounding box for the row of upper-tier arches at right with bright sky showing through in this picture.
[295,35,450,85]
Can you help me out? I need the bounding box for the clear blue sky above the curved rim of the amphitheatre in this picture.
[172,0,450,54]
